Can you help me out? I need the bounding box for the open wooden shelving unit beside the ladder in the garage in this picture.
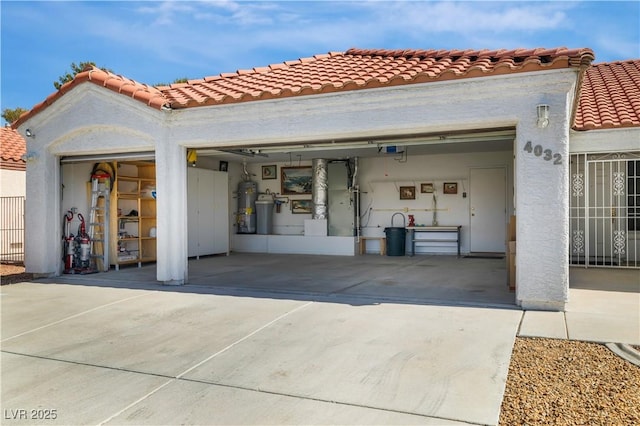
[110,161,156,270]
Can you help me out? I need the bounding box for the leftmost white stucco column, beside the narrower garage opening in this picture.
[25,146,63,277]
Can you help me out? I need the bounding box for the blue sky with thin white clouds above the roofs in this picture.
[0,0,640,125]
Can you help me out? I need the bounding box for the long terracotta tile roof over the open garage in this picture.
[13,47,594,128]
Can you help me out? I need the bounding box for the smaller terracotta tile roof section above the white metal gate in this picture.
[573,59,640,130]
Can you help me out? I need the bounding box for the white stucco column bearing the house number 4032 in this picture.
[514,97,569,311]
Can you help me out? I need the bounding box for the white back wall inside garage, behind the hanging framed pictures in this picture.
[218,147,514,252]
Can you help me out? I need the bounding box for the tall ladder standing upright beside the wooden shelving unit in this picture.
[89,173,111,272]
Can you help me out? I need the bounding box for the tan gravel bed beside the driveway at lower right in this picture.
[499,338,640,425]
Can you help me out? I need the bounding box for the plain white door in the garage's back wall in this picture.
[469,167,507,253]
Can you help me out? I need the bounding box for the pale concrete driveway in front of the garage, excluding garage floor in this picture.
[2,279,523,425]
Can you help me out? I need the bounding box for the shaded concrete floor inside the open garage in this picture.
[57,253,515,308]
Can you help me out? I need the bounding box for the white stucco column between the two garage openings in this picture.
[156,140,188,285]
